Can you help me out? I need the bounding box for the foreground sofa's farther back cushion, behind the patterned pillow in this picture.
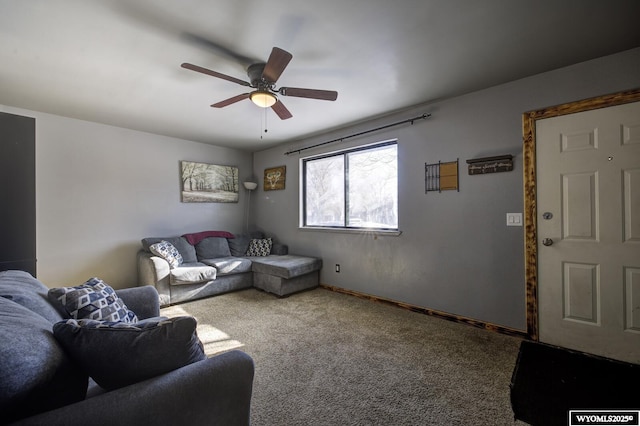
[0,271,62,323]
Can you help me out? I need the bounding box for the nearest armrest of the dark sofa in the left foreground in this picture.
[12,350,254,426]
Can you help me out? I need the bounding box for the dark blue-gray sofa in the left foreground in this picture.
[0,271,254,426]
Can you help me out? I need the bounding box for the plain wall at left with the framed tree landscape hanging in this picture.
[0,105,252,288]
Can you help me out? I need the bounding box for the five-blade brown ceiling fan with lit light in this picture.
[181,47,338,120]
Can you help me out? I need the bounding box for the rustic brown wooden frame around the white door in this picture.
[522,89,640,340]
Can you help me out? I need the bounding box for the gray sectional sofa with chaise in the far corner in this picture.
[137,231,322,306]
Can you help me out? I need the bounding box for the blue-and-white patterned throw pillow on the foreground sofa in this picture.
[48,277,138,323]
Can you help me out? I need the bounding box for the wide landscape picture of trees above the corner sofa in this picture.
[180,161,239,203]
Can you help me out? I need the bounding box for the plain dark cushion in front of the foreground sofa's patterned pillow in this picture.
[53,316,206,390]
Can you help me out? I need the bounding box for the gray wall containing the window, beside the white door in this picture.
[251,49,640,330]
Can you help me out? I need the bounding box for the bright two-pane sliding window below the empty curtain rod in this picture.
[302,141,398,230]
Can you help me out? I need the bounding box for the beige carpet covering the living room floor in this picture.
[162,288,522,426]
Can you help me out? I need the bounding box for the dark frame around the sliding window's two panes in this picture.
[299,139,401,235]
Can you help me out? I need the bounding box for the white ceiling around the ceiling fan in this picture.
[0,0,640,151]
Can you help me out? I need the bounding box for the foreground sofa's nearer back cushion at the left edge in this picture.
[0,297,88,424]
